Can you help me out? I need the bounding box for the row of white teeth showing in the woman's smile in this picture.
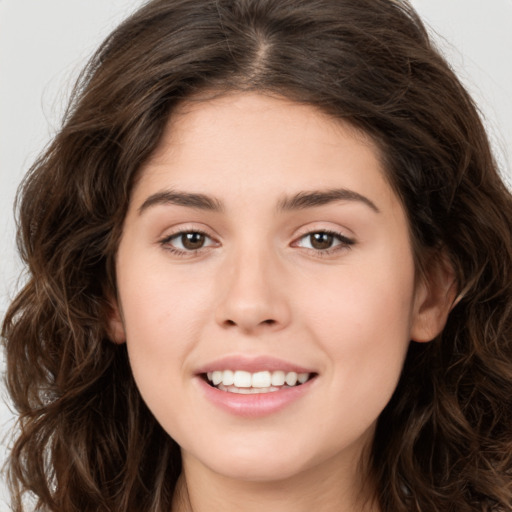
[207,370,310,388]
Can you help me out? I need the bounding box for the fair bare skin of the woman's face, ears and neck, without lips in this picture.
[111,93,451,512]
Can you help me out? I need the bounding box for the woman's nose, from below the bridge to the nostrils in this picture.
[216,245,291,334]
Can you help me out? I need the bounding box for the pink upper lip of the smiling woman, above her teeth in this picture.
[197,355,314,374]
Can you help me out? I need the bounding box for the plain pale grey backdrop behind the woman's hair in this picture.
[0,0,512,511]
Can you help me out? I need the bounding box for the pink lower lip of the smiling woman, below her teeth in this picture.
[198,377,316,418]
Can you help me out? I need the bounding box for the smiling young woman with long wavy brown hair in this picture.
[3,0,512,512]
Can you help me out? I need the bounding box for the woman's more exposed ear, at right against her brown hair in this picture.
[410,253,457,342]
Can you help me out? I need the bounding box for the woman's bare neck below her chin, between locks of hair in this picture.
[172,452,380,512]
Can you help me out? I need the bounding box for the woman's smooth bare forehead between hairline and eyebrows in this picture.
[133,93,392,201]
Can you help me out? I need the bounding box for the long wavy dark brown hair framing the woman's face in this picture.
[2,0,512,512]
